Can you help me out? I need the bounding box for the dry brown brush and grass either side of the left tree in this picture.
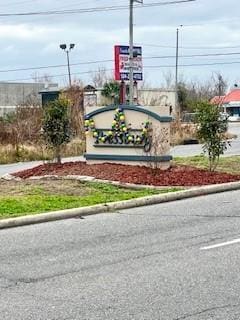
[0,100,85,164]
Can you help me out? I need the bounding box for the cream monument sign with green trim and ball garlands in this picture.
[85,105,171,168]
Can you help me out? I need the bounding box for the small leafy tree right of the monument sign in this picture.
[196,102,230,171]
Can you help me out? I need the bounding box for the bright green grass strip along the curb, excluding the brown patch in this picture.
[0,182,181,219]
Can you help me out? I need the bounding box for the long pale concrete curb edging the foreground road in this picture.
[0,182,240,229]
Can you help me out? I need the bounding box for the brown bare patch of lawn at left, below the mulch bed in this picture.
[0,179,91,196]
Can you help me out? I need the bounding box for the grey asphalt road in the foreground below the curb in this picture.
[0,191,240,320]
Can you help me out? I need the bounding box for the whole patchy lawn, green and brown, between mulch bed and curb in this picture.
[0,179,179,219]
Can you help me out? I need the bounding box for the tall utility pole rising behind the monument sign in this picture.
[129,0,143,105]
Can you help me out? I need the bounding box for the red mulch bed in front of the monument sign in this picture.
[14,162,240,186]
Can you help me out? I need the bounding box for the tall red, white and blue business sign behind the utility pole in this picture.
[114,46,143,81]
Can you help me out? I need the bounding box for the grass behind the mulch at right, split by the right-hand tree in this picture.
[174,155,240,174]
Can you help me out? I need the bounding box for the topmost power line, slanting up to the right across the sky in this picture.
[0,0,196,18]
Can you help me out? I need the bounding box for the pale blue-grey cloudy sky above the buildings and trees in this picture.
[0,0,240,87]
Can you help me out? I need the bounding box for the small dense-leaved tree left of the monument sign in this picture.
[42,98,71,163]
